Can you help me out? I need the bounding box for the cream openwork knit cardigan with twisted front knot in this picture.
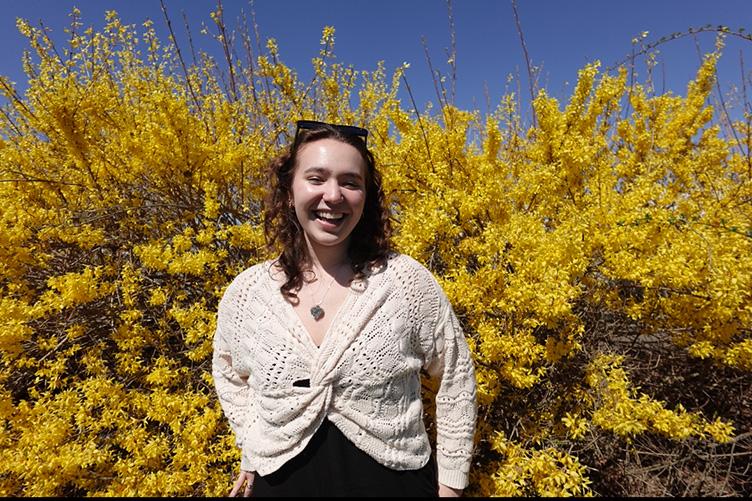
[212,254,476,489]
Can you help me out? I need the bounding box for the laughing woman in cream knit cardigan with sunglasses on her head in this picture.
[212,121,476,496]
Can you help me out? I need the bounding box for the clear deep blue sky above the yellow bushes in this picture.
[0,0,752,122]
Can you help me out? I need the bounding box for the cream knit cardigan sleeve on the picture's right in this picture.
[424,290,477,489]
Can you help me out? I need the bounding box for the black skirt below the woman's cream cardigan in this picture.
[251,419,439,497]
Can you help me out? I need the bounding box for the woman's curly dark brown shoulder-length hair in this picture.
[264,124,392,299]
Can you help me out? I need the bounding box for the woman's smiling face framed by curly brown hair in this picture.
[292,138,367,252]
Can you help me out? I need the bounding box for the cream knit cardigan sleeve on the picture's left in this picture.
[212,285,253,471]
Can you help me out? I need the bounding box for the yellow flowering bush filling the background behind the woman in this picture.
[0,10,752,496]
